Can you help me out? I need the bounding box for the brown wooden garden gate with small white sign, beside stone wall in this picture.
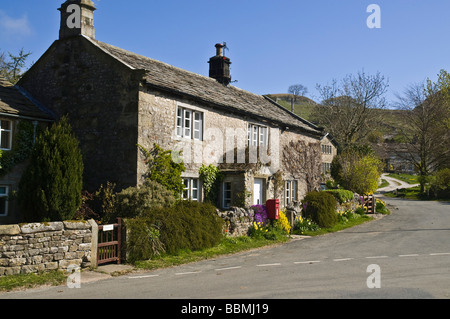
[97,218,122,266]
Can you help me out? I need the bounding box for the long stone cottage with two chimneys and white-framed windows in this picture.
[19,0,334,214]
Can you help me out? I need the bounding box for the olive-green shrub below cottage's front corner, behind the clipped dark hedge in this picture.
[110,180,176,221]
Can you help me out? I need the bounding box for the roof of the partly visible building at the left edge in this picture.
[0,76,52,120]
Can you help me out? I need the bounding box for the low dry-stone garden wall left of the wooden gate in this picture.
[0,220,98,276]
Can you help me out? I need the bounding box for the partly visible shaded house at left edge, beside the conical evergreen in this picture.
[0,76,53,225]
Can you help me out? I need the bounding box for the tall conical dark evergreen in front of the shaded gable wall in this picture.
[18,117,83,222]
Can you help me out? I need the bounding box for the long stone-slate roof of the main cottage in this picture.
[85,37,323,135]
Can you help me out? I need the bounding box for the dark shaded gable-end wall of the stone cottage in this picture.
[19,37,142,192]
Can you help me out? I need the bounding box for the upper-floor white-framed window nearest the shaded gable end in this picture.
[176,106,203,141]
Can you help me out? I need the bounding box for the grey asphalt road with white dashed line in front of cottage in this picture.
[0,198,450,300]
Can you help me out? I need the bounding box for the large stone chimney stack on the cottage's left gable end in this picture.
[58,0,96,40]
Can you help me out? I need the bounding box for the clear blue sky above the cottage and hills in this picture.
[0,0,450,106]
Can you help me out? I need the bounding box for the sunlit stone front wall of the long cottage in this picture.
[137,86,321,210]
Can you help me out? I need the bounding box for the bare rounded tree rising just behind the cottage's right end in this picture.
[313,71,389,147]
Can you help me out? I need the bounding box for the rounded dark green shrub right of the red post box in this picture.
[302,192,338,228]
